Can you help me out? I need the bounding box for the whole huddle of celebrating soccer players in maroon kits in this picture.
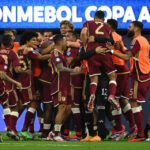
[0,10,150,142]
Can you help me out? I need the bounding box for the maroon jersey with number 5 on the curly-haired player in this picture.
[17,49,39,88]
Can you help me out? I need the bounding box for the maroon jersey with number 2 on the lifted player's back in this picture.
[83,20,111,51]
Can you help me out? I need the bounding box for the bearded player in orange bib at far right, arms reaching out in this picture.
[107,21,150,141]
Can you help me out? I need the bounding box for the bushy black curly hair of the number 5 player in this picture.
[20,31,38,45]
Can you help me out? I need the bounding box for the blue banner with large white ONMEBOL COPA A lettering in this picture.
[0,0,150,29]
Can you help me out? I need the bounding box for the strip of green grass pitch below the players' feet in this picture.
[0,133,150,150]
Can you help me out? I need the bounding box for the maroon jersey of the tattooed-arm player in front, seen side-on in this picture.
[51,49,70,95]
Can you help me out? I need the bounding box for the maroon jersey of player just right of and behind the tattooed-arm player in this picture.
[66,48,82,88]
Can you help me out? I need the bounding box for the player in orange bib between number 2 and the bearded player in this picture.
[107,19,137,140]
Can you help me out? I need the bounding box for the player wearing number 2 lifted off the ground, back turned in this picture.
[80,11,120,111]
